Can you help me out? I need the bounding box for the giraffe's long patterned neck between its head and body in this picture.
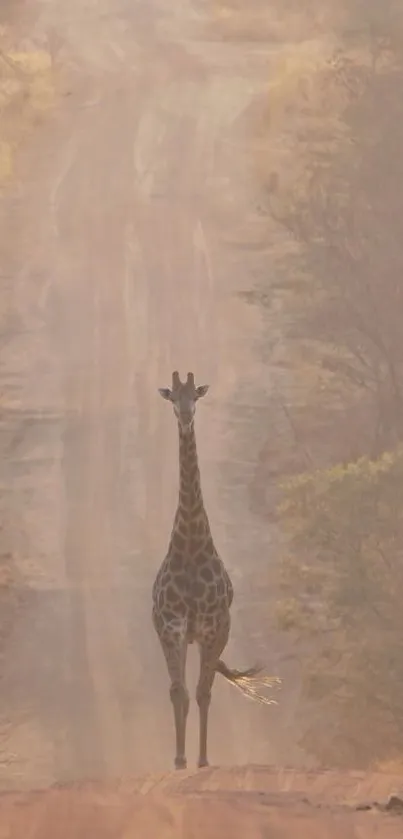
[174,423,208,528]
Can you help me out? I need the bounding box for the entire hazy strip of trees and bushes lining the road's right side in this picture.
[213,0,403,766]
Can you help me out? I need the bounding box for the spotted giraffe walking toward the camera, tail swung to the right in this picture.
[152,371,277,769]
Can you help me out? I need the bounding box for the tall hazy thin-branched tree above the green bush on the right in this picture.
[248,2,403,480]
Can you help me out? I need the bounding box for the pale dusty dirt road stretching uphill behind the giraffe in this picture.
[0,0,300,787]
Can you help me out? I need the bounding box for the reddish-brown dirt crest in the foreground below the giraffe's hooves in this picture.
[0,766,403,839]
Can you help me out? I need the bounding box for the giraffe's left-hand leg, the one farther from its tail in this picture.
[162,635,189,769]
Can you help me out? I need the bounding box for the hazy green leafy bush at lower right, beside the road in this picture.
[279,446,403,765]
